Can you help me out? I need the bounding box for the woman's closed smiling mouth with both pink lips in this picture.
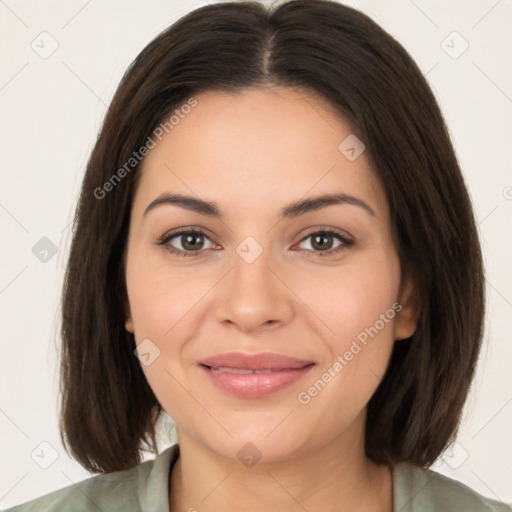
[199,353,315,398]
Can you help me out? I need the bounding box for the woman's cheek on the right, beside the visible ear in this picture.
[298,253,401,418]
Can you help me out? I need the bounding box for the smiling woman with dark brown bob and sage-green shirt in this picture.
[5,0,510,512]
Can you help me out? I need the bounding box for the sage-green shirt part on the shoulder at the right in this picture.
[394,463,512,512]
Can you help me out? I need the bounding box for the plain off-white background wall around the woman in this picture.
[0,0,512,508]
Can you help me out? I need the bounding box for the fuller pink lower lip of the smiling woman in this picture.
[199,364,314,398]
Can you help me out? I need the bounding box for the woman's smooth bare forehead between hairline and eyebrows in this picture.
[130,87,386,215]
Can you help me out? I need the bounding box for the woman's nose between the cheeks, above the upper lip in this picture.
[216,242,296,332]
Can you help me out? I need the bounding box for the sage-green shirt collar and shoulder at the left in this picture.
[4,448,175,512]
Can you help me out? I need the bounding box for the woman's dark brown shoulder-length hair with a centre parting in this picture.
[60,0,484,473]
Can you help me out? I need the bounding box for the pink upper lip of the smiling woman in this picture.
[199,352,313,370]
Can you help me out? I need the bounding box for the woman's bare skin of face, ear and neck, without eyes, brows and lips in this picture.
[125,87,417,512]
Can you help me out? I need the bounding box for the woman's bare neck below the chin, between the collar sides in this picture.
[169,416,393,512]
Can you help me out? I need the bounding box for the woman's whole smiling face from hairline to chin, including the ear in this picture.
[125,87,415,461]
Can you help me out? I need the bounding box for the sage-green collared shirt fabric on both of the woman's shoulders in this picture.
[4,444,512,512]
